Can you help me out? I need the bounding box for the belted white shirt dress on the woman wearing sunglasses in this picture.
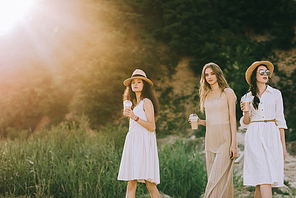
[240,86,287,187]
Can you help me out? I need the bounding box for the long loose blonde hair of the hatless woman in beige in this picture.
[199,63,229,112]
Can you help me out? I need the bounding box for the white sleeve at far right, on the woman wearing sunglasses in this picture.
[275,90,288,129]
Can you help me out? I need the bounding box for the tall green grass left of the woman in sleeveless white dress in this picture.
[0,118,125,197]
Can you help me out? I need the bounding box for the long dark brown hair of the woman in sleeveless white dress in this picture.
[123,80,159,116]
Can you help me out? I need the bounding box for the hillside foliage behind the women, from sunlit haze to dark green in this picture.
[0,0,296,136]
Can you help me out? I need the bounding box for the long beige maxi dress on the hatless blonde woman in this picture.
[204,91,236,198]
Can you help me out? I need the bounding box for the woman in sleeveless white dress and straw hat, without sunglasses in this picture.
[118,69,160,198]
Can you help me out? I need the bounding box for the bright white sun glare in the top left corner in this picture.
[0,0,33,31]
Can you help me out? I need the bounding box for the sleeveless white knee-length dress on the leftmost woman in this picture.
[118,99,160,184]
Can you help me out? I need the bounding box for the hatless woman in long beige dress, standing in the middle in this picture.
[194,63,237,198]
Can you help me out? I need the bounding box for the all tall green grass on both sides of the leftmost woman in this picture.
[0,120,206,198]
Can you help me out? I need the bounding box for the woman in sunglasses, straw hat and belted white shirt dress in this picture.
[240,61,287,198]
